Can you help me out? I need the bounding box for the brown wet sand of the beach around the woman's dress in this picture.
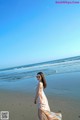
[0,90,80,120]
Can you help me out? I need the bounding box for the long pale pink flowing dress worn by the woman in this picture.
[36,81,62,120]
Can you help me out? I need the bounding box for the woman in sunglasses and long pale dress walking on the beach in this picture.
[34,72,62,120]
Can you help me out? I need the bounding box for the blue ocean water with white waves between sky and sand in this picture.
[0,56,80,98]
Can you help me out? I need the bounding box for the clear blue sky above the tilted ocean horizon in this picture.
[0,0,80,68]
